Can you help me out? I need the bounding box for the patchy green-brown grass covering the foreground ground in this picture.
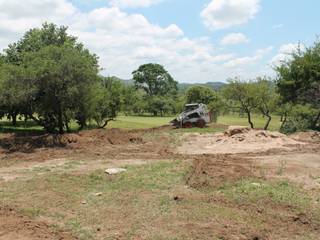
[0,161,318,240]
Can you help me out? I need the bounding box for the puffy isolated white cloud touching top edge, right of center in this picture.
[201,0,260,29]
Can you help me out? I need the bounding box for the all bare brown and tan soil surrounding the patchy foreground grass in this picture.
[0,126,320,240]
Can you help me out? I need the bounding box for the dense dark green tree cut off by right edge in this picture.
[275,40,320,128]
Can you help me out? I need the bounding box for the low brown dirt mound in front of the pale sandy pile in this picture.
[187,155,254,188]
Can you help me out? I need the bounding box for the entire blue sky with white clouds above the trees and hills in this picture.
[0,0,320,83]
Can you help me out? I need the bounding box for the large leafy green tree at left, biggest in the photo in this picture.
[0,24,99,133]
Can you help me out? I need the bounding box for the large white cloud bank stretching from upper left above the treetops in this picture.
[0,0,272,82]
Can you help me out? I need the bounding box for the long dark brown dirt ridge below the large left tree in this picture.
[0,129,143,152]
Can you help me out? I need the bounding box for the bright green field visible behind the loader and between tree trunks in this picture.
[0,114,280,132]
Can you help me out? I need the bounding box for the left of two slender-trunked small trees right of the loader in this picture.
[223,79,259,128]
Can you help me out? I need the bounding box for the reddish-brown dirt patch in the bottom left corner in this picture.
[0,207,77,240]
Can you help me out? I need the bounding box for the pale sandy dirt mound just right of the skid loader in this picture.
[177,127,306,154]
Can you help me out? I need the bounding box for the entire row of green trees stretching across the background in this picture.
[0,23,320,133]
